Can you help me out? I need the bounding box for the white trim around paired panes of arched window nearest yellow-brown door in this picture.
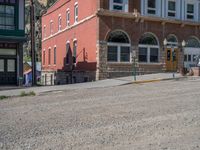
[138,44,160,64]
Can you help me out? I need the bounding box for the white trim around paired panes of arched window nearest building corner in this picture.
[107,42,132,64]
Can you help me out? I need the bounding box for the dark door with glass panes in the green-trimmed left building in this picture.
[0,58,17,85]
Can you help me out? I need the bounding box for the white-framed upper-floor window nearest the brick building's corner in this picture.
[110,0,128,12]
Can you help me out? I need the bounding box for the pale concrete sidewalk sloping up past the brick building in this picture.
[0,73,183,96]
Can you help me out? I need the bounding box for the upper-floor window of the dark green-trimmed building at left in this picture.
[0,4,16,30]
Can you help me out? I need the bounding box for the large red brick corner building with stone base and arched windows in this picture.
[42,0,200,85]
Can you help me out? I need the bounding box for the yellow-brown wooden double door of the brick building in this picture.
[166,49,178,71]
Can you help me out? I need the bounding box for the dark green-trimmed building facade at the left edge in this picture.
[0,0,25,85]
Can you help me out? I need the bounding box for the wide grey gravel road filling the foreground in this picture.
[0,80,200,150]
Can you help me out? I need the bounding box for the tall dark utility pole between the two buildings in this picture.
[30,0,37,86]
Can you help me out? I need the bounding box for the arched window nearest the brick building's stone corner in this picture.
[107,31,131,62]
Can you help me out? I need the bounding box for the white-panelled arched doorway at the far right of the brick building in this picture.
[184,36,200,70]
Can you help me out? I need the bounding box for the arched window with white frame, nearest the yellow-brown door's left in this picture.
[138,33,159,63]
